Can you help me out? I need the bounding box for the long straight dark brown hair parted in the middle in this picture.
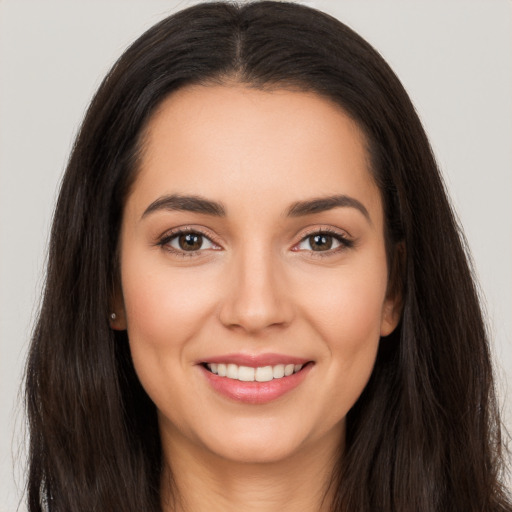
[26,2,512,512]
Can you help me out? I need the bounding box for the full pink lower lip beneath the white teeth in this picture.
[201,363,313,404]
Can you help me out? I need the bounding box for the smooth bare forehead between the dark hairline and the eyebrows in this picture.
[132,85,380,223]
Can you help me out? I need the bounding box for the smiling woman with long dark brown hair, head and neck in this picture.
[27,2,512,511]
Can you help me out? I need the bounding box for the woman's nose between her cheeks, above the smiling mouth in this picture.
[219,248,293,334]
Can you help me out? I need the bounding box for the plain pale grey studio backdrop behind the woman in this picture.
[0,0,512,512]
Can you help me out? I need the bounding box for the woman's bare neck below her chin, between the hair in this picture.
[162,426,341,512]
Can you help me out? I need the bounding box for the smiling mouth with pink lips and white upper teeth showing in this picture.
[200,354,313,404]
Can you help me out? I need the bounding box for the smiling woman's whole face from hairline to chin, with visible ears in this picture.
[113,85,398,462]
